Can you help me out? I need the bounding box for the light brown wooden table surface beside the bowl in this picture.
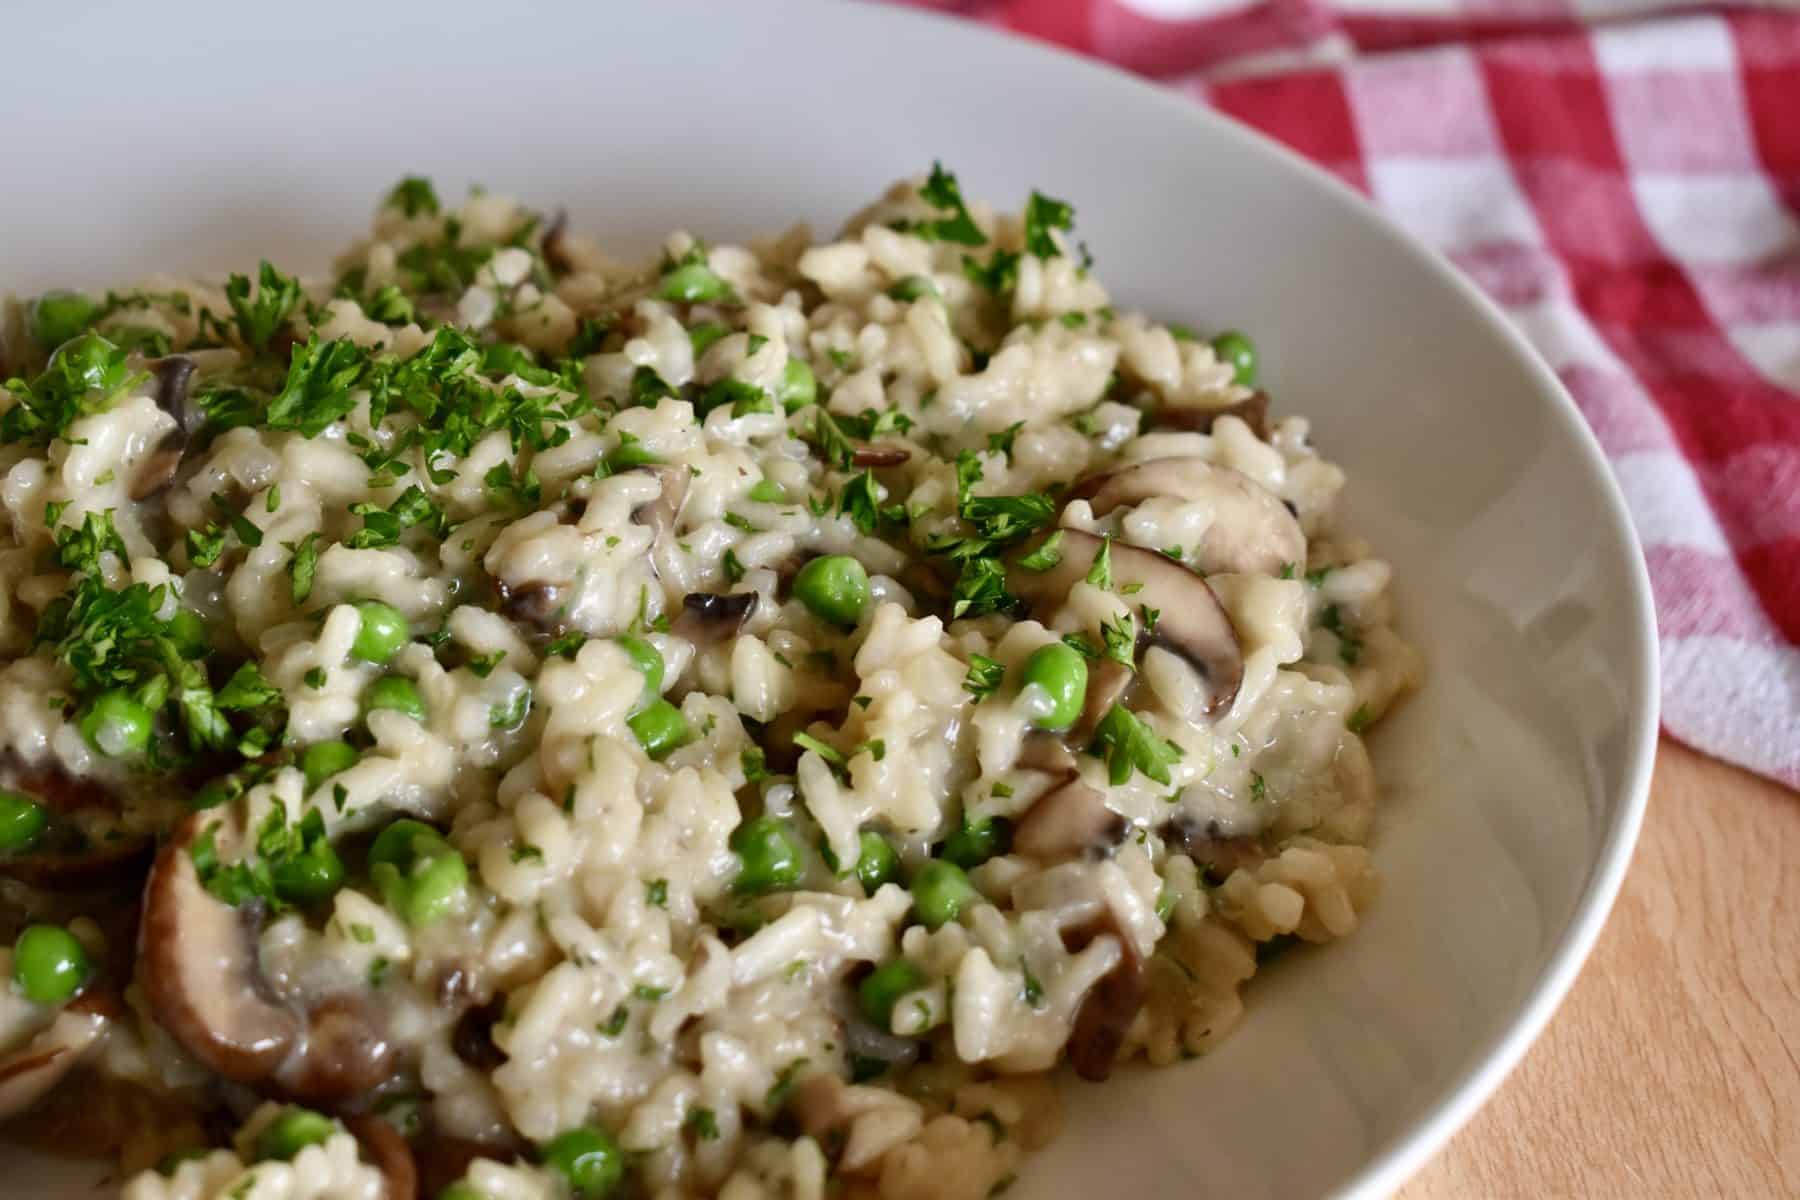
[1400,738,1800,1200]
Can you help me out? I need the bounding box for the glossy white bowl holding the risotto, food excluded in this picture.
[0,0,1656,1200]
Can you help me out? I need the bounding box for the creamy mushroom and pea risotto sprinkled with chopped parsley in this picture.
[0,167,1418,1200]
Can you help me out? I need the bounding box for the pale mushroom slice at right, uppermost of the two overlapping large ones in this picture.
[1069,455,1307,576]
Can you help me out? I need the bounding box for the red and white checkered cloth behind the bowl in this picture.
[892,0,1800,786]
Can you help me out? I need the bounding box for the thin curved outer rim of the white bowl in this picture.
[842,0,1661,1200]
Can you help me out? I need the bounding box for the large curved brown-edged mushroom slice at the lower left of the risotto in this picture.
[139,813,394,1103]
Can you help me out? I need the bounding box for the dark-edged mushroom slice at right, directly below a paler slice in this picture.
[1006,529,1244,712]
